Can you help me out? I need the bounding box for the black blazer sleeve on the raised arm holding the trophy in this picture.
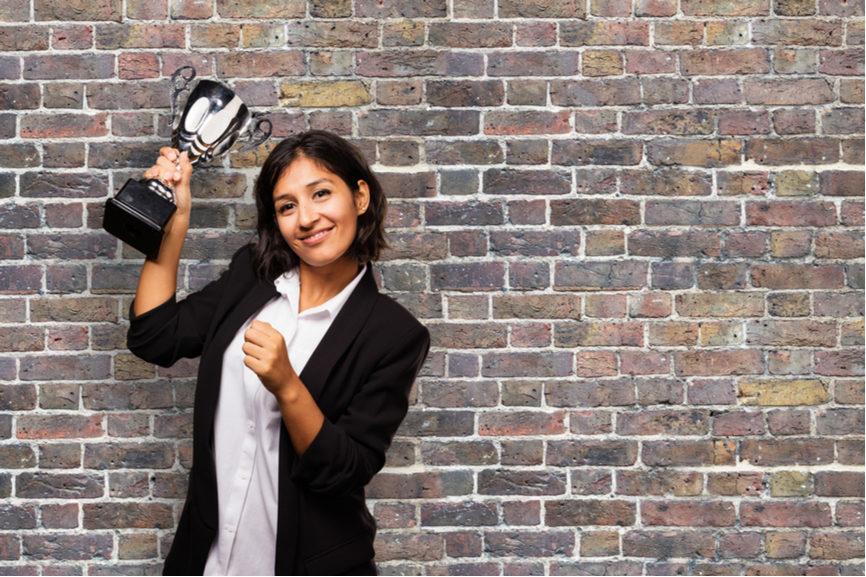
[126,247,245,367]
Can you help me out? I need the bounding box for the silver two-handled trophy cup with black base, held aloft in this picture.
[102,66,272,259]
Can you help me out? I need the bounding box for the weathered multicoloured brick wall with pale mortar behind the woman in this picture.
[0,0,864,575]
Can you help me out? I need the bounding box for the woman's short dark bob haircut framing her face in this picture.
[253,130,390,281]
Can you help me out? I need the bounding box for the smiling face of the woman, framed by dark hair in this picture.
[273,156,370,267]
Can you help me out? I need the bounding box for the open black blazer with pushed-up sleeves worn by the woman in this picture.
[127,244,430,575]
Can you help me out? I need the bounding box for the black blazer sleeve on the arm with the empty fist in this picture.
[290,324,430,496]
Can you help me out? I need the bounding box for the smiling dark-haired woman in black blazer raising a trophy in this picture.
[127,130,430,575]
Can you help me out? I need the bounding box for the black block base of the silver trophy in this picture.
[102,178,177,259]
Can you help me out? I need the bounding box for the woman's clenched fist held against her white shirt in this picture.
[241,320,297,399]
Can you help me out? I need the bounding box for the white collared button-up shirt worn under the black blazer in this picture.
[204,264,367,575]
